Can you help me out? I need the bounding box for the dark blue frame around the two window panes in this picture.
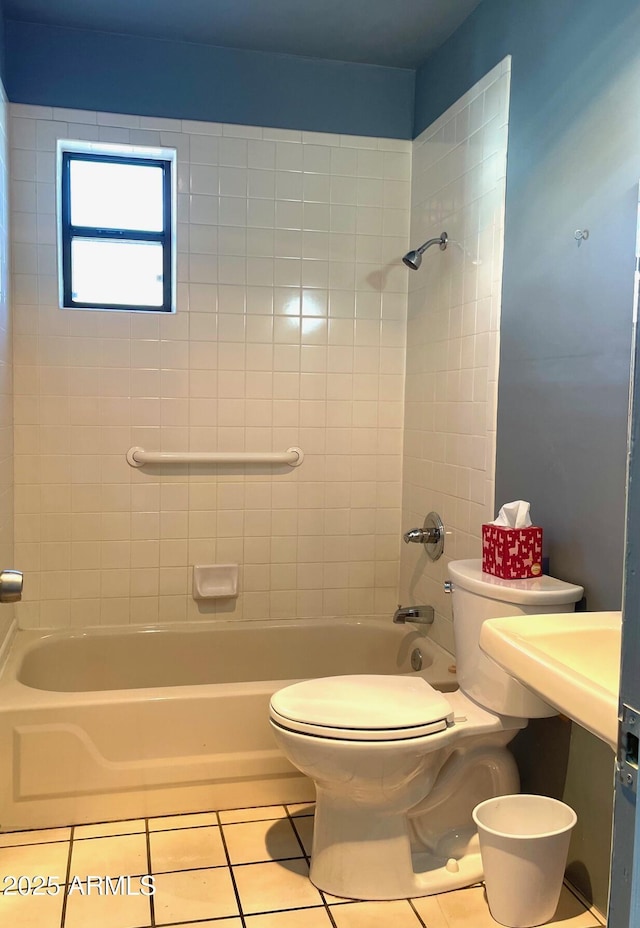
[61,150,173,313]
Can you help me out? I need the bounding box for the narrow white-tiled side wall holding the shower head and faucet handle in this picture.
[400,57,511,651]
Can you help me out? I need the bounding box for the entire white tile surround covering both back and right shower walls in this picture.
[11,59,510,632]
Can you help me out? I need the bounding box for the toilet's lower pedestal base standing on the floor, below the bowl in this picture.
[309,733,519,900]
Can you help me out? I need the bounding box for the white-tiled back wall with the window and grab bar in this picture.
[8,105,411,627]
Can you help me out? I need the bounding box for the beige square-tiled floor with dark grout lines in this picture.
[0,805,600,928]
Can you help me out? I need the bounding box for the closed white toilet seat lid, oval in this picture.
[270,674,453,741]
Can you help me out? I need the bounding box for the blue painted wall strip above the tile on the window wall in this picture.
[6,21,415,138]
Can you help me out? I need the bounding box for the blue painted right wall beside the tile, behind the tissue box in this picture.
[415,0,640,609]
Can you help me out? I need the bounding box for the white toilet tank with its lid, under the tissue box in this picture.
[448,559,584,719]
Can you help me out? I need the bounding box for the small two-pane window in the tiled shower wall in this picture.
[58,142,175,312]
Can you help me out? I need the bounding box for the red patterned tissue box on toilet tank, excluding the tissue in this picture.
[482,524,542,580]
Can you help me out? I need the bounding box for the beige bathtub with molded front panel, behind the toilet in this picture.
[0,620,456,831]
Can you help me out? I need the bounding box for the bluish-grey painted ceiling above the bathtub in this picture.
[4,0,480,68]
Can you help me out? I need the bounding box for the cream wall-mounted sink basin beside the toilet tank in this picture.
[480,612,622,750]
